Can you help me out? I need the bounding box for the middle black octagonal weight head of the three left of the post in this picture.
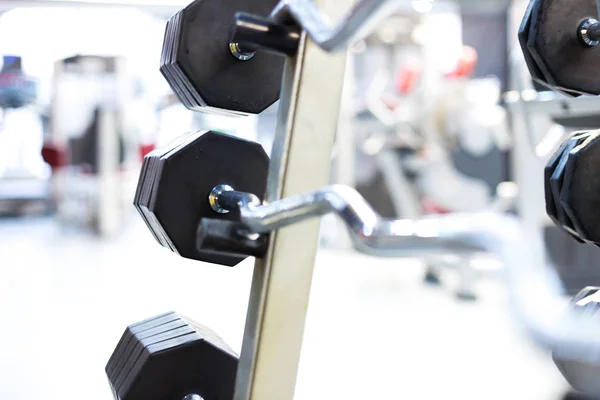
[134,131,326,266]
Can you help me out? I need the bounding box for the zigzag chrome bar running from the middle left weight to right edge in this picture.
[210,185,600,358]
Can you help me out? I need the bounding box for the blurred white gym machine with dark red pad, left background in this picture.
[42,56,140,236]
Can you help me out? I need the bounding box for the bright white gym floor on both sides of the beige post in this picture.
[0,218,567,400]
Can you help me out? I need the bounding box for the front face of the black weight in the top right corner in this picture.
[532,0,600,95]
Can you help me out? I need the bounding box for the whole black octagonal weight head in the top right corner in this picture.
[518,0,600,96]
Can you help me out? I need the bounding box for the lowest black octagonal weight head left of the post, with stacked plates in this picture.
[106,312,238,400]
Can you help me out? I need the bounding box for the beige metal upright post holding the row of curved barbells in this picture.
[235,0,350,399]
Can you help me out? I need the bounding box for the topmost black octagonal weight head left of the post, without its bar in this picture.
[161,0,284,114]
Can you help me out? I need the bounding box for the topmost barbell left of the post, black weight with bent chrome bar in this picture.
[160,0,404,115]
